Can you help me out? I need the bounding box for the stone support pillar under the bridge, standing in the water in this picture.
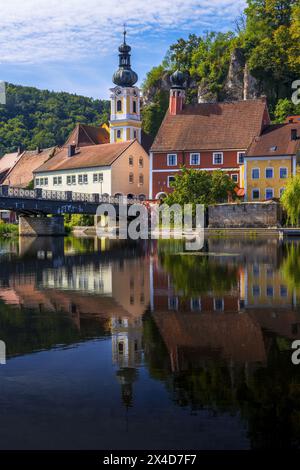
[19,215,65,237]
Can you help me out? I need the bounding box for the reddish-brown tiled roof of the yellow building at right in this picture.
[247,123,300,157]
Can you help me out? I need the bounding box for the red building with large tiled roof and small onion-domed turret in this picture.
[150,71,270,199]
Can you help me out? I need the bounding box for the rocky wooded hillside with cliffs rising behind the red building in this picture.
[143,0,300,135]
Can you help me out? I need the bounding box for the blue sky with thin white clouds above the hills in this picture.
[0,0,246,98]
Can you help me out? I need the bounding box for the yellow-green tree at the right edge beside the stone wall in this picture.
[280,174,300,225]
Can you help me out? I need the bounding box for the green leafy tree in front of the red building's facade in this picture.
[164,167,236,206]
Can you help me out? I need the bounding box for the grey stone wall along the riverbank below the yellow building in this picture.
[208,201,281,228]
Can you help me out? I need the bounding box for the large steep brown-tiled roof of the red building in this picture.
[151,99,269,152]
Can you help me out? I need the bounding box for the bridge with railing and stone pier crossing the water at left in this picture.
[0,185,139,236]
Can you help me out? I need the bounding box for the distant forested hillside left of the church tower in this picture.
[0,83,109,156]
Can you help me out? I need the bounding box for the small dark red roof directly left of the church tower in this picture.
[65,124,109,147]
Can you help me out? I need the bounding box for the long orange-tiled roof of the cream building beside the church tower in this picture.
[34,140,135,173]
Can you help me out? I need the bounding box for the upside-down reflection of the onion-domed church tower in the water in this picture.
[111,317,143,408]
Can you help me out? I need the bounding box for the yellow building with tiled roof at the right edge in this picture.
[241,123,300,201]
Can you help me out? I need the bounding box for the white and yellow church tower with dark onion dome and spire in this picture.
[110,30,142,143]
